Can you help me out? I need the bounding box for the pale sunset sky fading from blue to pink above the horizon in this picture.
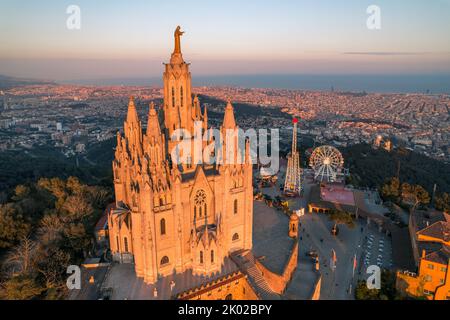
[0,0,450,81]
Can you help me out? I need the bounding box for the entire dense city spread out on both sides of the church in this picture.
[0,85,450,162]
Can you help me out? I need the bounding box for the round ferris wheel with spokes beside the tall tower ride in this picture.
[309,146,344,182]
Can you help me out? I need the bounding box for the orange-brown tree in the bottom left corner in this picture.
[3,275,44,300]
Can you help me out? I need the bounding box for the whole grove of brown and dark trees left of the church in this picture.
[0,177,110,299]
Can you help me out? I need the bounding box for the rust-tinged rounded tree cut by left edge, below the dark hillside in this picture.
[0,203,30,248]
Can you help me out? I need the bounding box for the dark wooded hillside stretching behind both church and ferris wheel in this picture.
[0,138,450,198]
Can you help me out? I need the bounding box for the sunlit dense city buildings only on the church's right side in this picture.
[194,87,450,161]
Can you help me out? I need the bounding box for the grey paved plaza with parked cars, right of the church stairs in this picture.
[299,214,392,300]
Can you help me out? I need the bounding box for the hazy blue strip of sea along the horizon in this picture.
[60,74,450,94]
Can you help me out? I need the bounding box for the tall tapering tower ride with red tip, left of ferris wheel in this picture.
[284,118,302,195]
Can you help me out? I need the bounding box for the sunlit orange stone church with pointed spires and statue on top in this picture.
[108,27,253,284]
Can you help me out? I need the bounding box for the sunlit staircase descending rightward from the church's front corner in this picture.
[231,250,281,300]
